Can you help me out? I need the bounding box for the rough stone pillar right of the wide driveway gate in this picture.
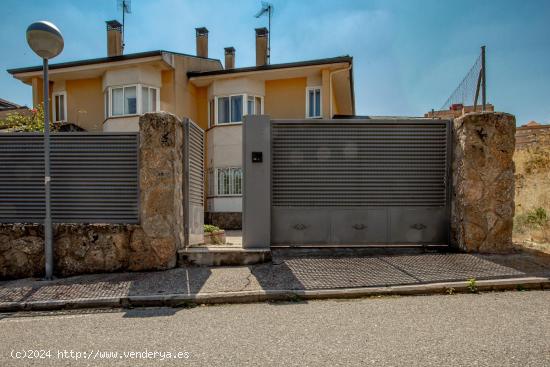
[451,112,516,253]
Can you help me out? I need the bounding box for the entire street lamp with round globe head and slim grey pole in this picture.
[27,21,64,280]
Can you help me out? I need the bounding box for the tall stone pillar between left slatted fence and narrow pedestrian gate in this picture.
[129,112,184,270]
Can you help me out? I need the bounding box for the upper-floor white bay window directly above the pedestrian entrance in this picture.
[209,94,264,126]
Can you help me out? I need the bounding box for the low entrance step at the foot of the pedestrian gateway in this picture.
[178,246,271,266]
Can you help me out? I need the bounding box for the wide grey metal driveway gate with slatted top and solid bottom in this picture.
[270,119,451,246]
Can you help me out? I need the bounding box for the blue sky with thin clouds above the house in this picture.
[0,0,550,124]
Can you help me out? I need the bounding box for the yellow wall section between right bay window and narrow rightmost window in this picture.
[264,78,307,119]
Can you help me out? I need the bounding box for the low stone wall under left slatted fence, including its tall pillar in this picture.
[0,113,184,279]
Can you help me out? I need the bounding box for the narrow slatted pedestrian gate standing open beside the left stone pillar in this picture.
[183,119,204,247]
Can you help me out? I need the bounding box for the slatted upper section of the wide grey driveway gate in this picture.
[272,121,449,207]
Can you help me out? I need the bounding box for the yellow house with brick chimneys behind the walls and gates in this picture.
[8,21,355,229]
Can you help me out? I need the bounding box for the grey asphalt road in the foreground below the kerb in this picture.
[0,291,550,367]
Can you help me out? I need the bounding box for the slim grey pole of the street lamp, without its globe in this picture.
[43,59,53,280]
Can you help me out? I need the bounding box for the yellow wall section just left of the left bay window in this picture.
[65,78,105,131]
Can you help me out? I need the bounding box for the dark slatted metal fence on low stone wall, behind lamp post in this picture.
[0,133,139,223]
